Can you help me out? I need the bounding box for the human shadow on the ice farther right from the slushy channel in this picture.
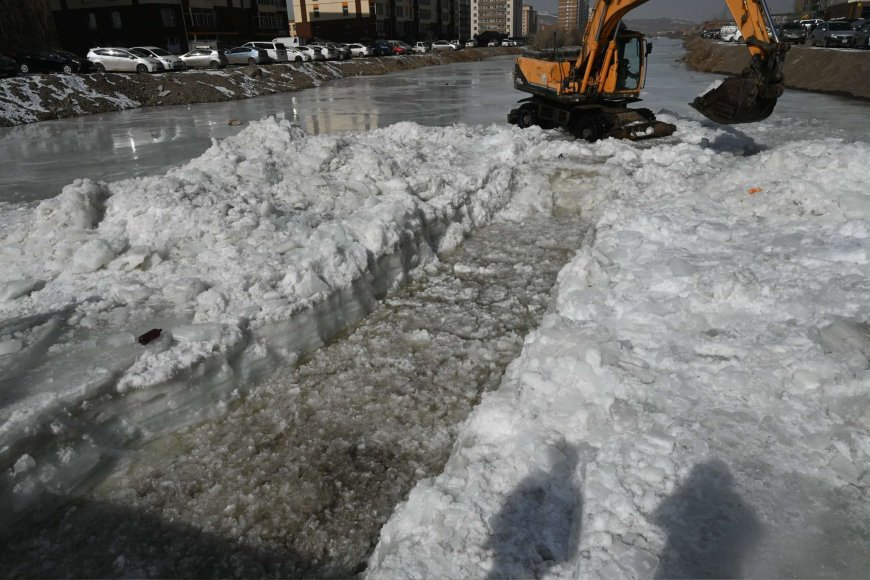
[653,459,761,578]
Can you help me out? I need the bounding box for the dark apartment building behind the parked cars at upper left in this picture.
[51,0,288,54]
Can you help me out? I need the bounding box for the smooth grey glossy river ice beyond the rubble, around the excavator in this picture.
[0,39,870,201]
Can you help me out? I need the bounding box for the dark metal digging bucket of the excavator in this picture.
[691,74,777,125]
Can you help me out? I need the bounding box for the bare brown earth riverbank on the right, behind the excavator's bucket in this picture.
[683,37,870,99]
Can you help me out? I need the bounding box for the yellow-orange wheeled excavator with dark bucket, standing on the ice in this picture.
[508,0,789,141]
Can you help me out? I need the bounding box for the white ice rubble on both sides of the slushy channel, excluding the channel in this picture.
[0,114,870,578]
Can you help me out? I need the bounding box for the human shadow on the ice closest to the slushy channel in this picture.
[487,446,583,579]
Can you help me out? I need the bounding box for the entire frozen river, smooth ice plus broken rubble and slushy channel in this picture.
[0,41,870,578]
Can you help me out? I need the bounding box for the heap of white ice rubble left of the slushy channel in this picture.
[0,119,548,524]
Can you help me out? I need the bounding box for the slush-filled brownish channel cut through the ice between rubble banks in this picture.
[0,216,586,578]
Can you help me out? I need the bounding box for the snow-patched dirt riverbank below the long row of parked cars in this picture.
[0,47,519,127]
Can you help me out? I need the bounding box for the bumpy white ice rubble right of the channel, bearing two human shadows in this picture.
[368,135,870,578]
